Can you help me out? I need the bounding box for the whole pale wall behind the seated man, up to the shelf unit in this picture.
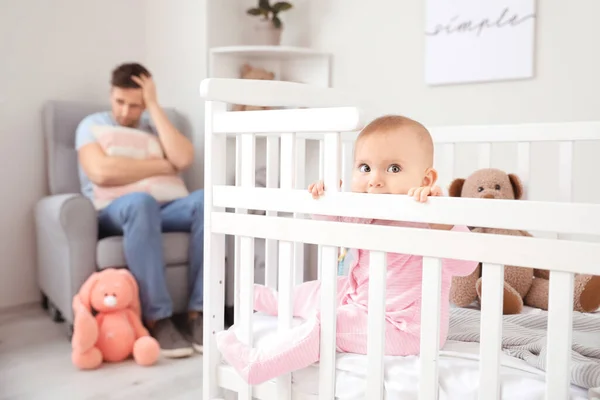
[0,0,211,309]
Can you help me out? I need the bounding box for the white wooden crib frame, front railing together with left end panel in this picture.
[203,78,600,399]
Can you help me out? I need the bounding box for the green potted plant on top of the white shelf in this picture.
[247,0,292,46]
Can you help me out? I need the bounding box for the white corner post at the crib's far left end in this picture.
[202,101,227,399]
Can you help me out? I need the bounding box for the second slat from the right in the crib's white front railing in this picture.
[479,263,504,400]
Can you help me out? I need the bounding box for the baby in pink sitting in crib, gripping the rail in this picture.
[216,115,477,384]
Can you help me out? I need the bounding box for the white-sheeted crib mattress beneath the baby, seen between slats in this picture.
[219,313,588,400]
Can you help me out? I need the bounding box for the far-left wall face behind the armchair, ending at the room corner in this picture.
[0,0,146,308]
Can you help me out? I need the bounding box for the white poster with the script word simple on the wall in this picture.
[425,0,536,85]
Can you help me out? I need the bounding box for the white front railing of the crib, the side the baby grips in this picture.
[213,193,600,399]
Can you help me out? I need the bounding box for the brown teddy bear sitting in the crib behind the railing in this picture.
[449,168,600,314]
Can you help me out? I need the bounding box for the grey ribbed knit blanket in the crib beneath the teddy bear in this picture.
[448,308,600,389]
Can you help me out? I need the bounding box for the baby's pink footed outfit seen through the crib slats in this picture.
[216,216,478,385]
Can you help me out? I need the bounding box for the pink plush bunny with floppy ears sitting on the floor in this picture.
[71,268,160,369]
